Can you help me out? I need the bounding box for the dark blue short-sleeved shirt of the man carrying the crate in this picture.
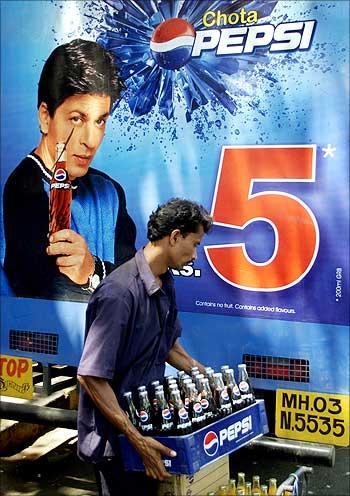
[78,249,181,462]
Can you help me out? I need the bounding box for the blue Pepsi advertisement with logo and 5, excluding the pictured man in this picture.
[1,0,349,393]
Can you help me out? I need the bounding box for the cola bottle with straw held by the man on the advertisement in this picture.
[49,143,72,235]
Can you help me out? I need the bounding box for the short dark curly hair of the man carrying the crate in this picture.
[147,198,213,241]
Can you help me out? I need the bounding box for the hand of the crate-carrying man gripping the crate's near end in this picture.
[134,436,176,481]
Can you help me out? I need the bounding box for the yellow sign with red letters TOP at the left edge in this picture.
[0,355,33,400]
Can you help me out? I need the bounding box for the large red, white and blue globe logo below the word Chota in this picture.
[150,17,196,70]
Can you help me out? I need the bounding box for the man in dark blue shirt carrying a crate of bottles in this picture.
[78,199,212,496]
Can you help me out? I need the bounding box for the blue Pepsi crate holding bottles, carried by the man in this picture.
[119,400,268,475]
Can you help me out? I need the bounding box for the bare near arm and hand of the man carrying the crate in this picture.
[78,375,176,481]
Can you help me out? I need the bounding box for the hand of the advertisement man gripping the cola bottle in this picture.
[46,229,94,284]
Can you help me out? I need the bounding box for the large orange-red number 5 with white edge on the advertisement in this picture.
[205,145,319,291]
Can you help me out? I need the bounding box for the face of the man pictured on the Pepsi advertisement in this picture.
[38,94,111,180]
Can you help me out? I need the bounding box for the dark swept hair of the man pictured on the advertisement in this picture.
[38,39,123,117]
